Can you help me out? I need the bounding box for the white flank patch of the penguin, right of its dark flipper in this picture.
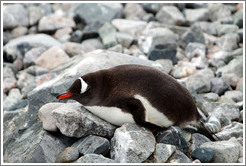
[134,94,173,127]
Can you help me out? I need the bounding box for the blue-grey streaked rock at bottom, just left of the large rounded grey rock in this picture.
[72,135,110,156]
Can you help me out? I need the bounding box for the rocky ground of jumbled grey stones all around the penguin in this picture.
[3,3,244,163]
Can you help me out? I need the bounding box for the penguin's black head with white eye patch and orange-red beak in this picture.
[56,77,90,102]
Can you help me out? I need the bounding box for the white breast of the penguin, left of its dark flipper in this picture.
[85,106,135,126]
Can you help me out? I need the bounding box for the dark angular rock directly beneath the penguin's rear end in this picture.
[156,127,189,153]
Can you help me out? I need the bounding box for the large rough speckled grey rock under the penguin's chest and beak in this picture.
[52,103,115,138]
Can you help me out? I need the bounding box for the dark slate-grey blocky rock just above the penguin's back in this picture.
[148,48,177,64]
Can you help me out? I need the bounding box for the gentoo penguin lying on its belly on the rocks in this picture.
[57,65,214,139]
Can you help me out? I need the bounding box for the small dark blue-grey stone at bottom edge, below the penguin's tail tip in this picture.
[191,148,214,163]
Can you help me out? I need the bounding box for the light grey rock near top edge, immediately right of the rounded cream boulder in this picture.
[184,8,209,23]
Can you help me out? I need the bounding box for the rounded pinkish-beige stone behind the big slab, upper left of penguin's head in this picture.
[35,46,69,70]
